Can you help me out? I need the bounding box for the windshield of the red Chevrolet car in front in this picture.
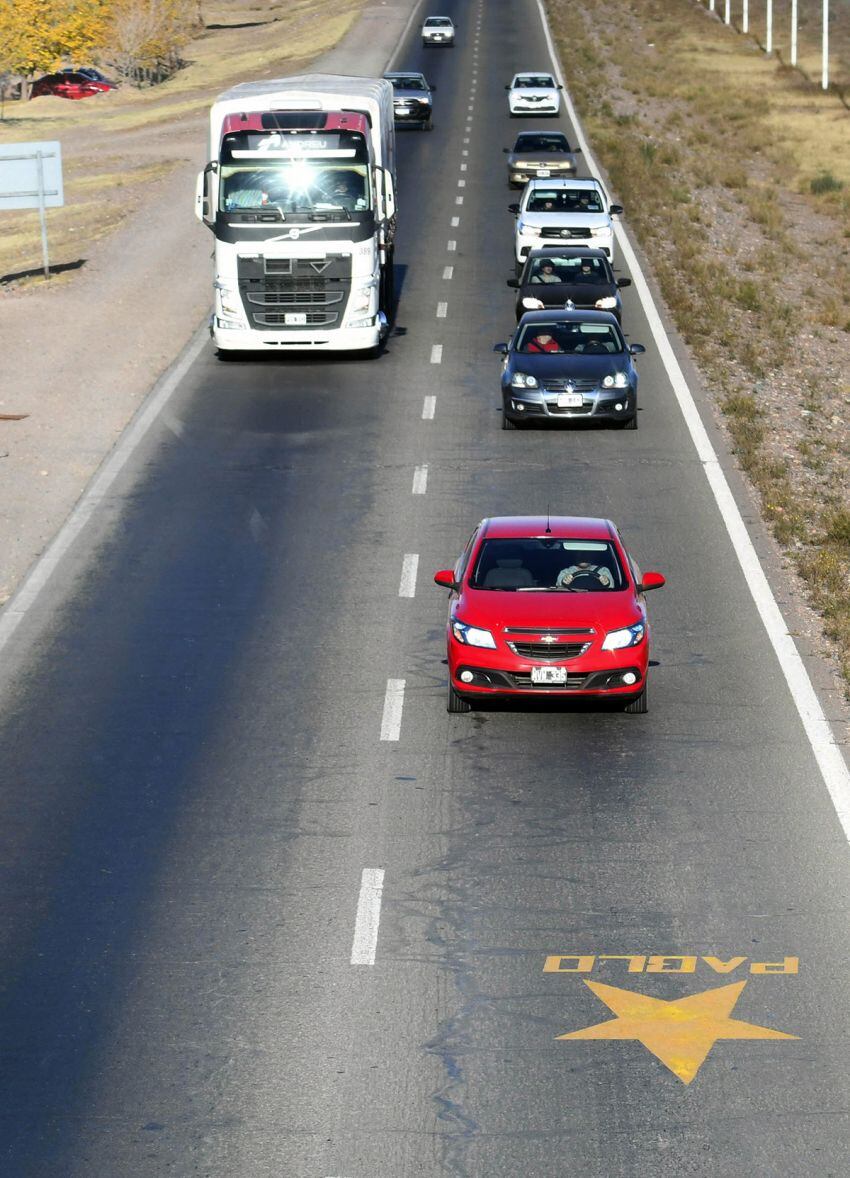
[470,536,627,593]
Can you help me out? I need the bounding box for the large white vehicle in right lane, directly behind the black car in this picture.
[509,179,623,269]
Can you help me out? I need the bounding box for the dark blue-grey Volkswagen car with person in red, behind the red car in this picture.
[493,311,646,430]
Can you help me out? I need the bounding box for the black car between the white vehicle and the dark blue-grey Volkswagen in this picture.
[507,246,631,322]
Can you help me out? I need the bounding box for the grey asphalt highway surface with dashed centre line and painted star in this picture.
[0,0,850,1178]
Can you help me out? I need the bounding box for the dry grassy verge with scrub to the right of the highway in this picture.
[550,0,850,683]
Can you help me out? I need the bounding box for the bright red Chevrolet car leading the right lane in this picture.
[434,516,664,712]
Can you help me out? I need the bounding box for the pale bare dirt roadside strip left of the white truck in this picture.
[0,0,417,604]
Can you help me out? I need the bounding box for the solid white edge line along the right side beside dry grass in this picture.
[537,0,850,840]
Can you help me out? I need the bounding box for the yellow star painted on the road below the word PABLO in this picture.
[557,980,798,1084]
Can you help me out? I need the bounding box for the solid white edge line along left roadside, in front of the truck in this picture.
[0,325,210,650]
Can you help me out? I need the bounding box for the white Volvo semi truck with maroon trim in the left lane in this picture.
[195,74,396,358]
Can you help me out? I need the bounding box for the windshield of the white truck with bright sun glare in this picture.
[219,159,372,213]
